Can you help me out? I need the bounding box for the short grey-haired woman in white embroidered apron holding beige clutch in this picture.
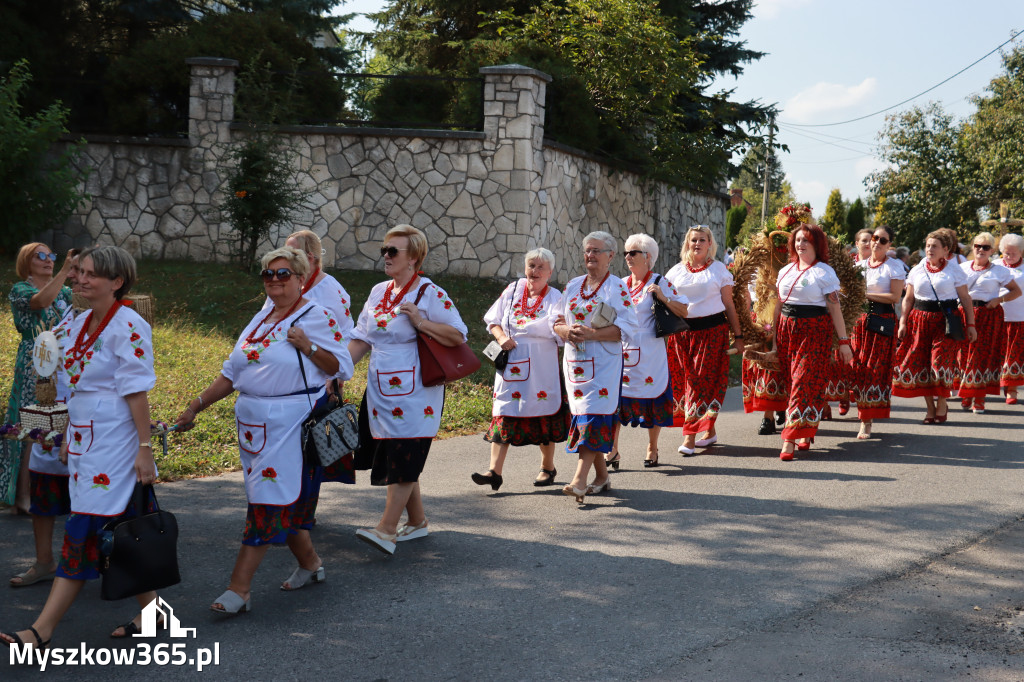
[555,231,637,503]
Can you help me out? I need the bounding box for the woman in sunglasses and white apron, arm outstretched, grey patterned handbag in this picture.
[177,247,352,614]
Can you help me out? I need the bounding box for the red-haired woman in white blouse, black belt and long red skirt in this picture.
[773,223,853,462]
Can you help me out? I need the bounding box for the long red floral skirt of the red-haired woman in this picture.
[775,315,835,440]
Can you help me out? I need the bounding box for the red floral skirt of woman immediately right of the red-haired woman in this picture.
[847,312,896,422]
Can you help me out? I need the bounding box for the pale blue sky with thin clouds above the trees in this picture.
[331,0,1024,214]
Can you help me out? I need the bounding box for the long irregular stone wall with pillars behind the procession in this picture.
[49,57,729,282]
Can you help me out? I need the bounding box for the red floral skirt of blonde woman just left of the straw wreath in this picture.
[667,325,729,435]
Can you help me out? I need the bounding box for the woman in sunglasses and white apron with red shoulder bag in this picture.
[348,225,467,554]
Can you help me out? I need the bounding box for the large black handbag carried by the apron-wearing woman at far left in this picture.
[99,483,181,601]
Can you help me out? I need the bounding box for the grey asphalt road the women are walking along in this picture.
[0,389,1024,681]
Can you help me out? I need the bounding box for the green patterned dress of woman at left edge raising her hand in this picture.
[0,282,71,505]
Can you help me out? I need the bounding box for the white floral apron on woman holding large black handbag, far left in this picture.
[68,391,138,516]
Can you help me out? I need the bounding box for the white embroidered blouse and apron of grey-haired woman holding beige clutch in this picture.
[562,275,637,415]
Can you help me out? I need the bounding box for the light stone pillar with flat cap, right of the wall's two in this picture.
[480,65,551,279]
